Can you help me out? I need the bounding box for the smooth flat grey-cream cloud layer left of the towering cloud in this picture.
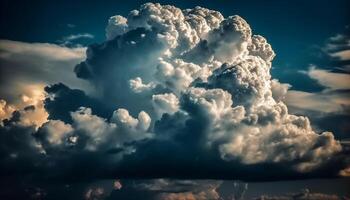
[0,40,89,104]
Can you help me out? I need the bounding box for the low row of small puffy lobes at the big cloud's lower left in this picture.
[36,107,152,152]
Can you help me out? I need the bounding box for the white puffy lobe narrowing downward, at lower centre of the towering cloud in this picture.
[180,88,245,146]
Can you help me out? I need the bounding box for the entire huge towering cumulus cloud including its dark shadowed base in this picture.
[1,3,346,186]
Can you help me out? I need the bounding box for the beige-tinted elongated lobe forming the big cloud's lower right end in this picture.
[220,117,341,172]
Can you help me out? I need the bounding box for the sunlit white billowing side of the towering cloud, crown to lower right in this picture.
[93,3,341,171]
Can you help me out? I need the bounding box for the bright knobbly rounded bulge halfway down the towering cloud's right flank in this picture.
[207,56,274,108]
